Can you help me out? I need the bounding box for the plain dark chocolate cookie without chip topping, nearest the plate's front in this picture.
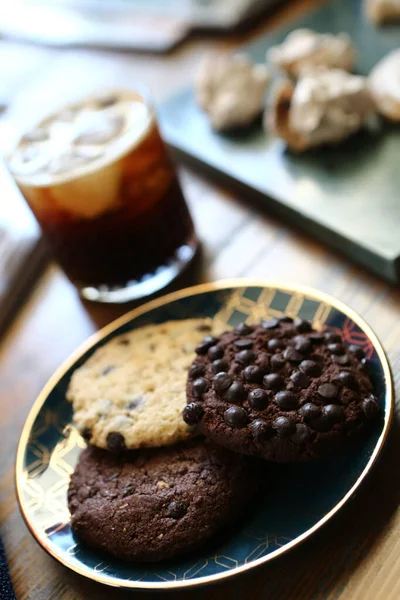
[68,438,259,561]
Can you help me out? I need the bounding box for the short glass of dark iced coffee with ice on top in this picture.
[7,91,197,302]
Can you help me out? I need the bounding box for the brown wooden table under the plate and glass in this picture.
[0,0,400,600]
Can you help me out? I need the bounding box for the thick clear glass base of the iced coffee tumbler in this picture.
[78,238,198,304]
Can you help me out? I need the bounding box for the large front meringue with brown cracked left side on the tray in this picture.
[266,69,374,152]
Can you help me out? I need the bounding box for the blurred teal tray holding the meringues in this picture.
[160,0,400,283]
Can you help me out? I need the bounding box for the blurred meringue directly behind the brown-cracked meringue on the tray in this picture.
[267,29,356,79]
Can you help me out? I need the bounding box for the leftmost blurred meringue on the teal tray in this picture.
[195,54,269,131]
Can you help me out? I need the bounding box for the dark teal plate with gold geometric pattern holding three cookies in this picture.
[16,280,394,589]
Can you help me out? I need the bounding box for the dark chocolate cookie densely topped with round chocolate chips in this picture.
[183,317,379,462]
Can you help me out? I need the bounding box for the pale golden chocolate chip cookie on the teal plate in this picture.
[67,319,211,452]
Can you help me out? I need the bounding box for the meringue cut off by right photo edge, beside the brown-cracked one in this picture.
[368,48,400,122]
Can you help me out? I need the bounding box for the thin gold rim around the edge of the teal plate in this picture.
[15,278,394,590]
